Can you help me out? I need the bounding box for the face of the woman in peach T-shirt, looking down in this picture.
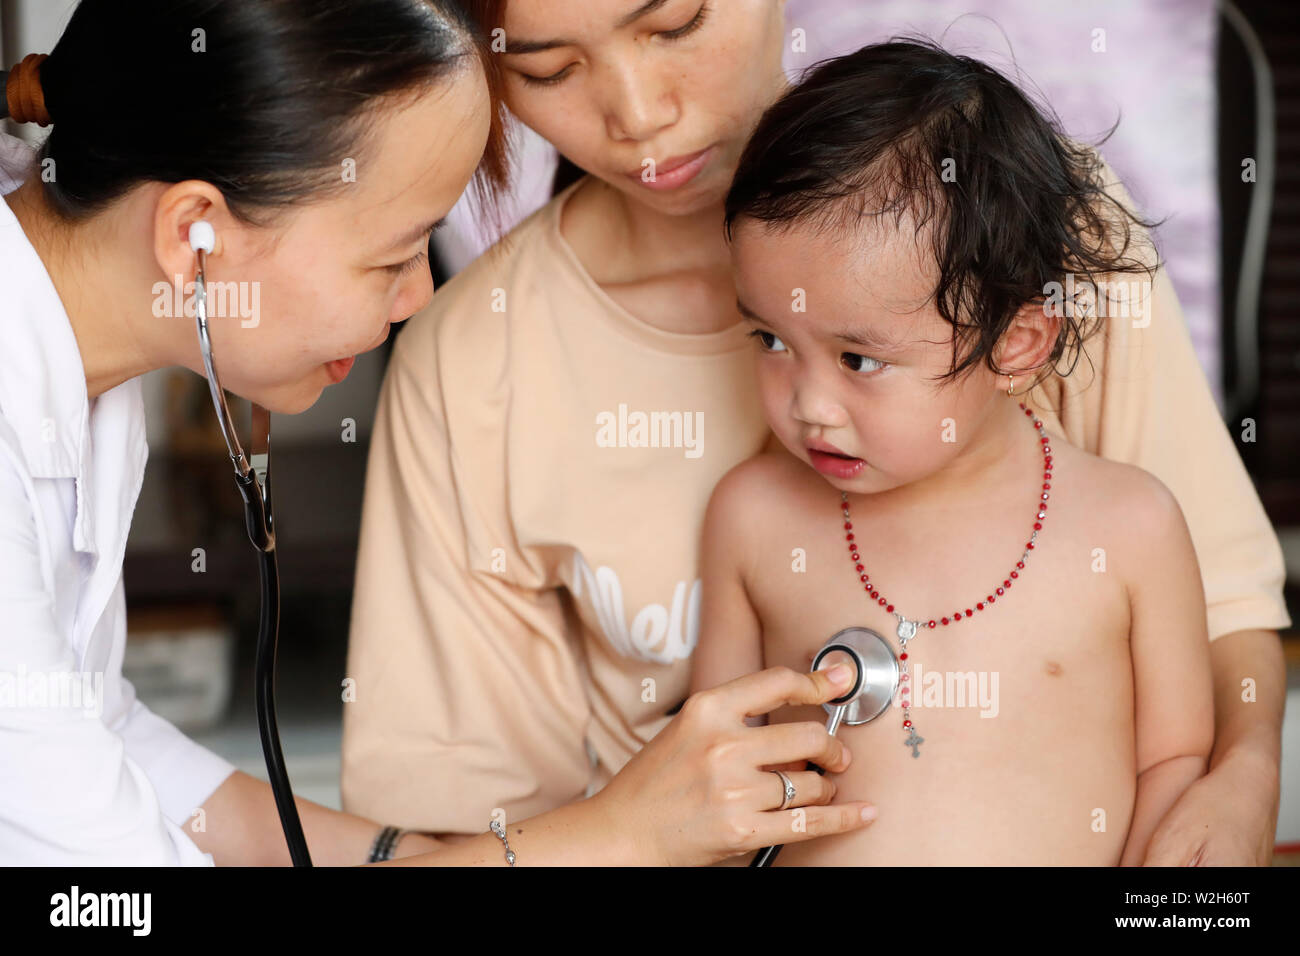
[494,0,787,215]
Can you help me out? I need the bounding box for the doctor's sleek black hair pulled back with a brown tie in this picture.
[30,0,507,221]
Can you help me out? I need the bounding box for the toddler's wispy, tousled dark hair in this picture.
[725,38,1157,382]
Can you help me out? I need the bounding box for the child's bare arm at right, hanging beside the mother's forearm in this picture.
[1119,472,1214,866]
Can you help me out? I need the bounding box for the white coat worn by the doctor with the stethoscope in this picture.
[0,134,234,866]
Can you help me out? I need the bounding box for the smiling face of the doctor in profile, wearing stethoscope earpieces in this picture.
[182,65,490,414]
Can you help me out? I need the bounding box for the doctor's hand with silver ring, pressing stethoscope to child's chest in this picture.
[590,667,875,866]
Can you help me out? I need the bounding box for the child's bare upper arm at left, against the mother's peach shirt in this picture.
[690,462,764,712]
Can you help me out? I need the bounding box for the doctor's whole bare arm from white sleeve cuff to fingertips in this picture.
[190,667,871,866]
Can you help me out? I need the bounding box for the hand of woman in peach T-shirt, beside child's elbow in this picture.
[1141,756,1278,866]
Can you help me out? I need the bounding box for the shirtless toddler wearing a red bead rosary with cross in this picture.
[692,42,1214,865]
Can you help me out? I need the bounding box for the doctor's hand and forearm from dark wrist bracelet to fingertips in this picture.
[384,667,875,866]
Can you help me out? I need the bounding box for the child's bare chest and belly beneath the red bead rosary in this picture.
[748,476,1134,864]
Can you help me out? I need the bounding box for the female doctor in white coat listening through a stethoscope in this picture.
[0,0,874,865]
